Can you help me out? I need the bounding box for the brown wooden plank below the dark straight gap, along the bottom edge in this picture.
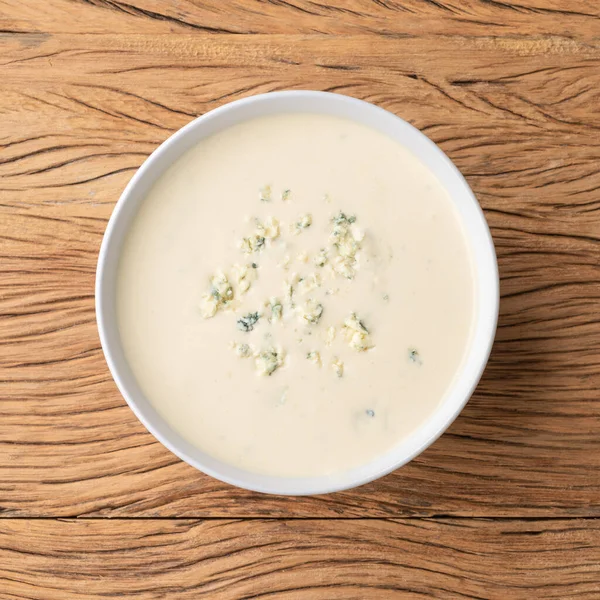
[0,519,600,600]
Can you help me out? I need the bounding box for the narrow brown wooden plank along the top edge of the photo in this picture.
[0,0,600,44]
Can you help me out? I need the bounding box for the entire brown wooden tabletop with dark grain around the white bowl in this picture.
[0,0,600,600]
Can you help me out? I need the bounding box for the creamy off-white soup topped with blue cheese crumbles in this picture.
[117,114,475,476]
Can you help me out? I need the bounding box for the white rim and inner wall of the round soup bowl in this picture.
[96,91,499,495]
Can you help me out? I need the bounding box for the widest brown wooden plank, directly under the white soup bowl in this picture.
[0,32,600,517]
